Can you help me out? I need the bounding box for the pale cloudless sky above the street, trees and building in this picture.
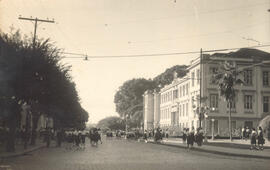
[0,0,270,123]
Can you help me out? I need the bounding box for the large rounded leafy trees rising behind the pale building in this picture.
[114,65,187,128]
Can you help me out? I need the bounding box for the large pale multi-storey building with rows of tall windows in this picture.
[144,49,270,136]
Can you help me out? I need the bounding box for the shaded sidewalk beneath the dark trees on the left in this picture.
[0,139,46,159]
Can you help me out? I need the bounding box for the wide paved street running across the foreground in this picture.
[0,139,270,170]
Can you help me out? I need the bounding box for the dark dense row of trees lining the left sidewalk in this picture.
[0,31,88,151]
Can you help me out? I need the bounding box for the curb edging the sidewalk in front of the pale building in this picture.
[148,141,270,159]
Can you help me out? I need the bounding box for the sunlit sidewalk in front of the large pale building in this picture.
[148,138,270,159]
